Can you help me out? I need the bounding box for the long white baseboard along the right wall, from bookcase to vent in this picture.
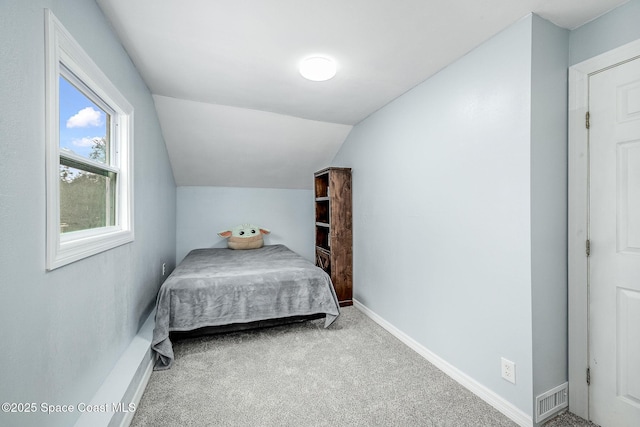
[353,299,533,427]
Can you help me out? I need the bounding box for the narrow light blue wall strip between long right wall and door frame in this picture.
[531,15,569,422]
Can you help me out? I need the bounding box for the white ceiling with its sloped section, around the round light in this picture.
[96,0,627,188]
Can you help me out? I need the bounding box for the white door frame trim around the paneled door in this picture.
[567,40,640,419]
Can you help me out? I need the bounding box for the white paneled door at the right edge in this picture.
[589,59,640,427]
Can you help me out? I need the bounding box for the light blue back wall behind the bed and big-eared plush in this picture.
[176,187,314,262]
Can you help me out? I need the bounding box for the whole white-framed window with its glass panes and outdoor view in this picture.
[46,11,133,270]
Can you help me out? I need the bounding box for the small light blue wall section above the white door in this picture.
[569,0,640,65]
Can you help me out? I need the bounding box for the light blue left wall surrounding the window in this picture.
[0,0,176,426]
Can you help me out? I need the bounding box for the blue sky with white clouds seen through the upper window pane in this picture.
[59,76,107,163]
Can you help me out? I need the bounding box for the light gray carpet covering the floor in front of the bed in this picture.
[132,307,592,427]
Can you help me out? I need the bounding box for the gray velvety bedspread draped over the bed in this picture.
[151,245,340,370]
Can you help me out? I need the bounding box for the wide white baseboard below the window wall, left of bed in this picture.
[75,310,155,427]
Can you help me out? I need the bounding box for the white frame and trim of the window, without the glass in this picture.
[45,9,134,270]
